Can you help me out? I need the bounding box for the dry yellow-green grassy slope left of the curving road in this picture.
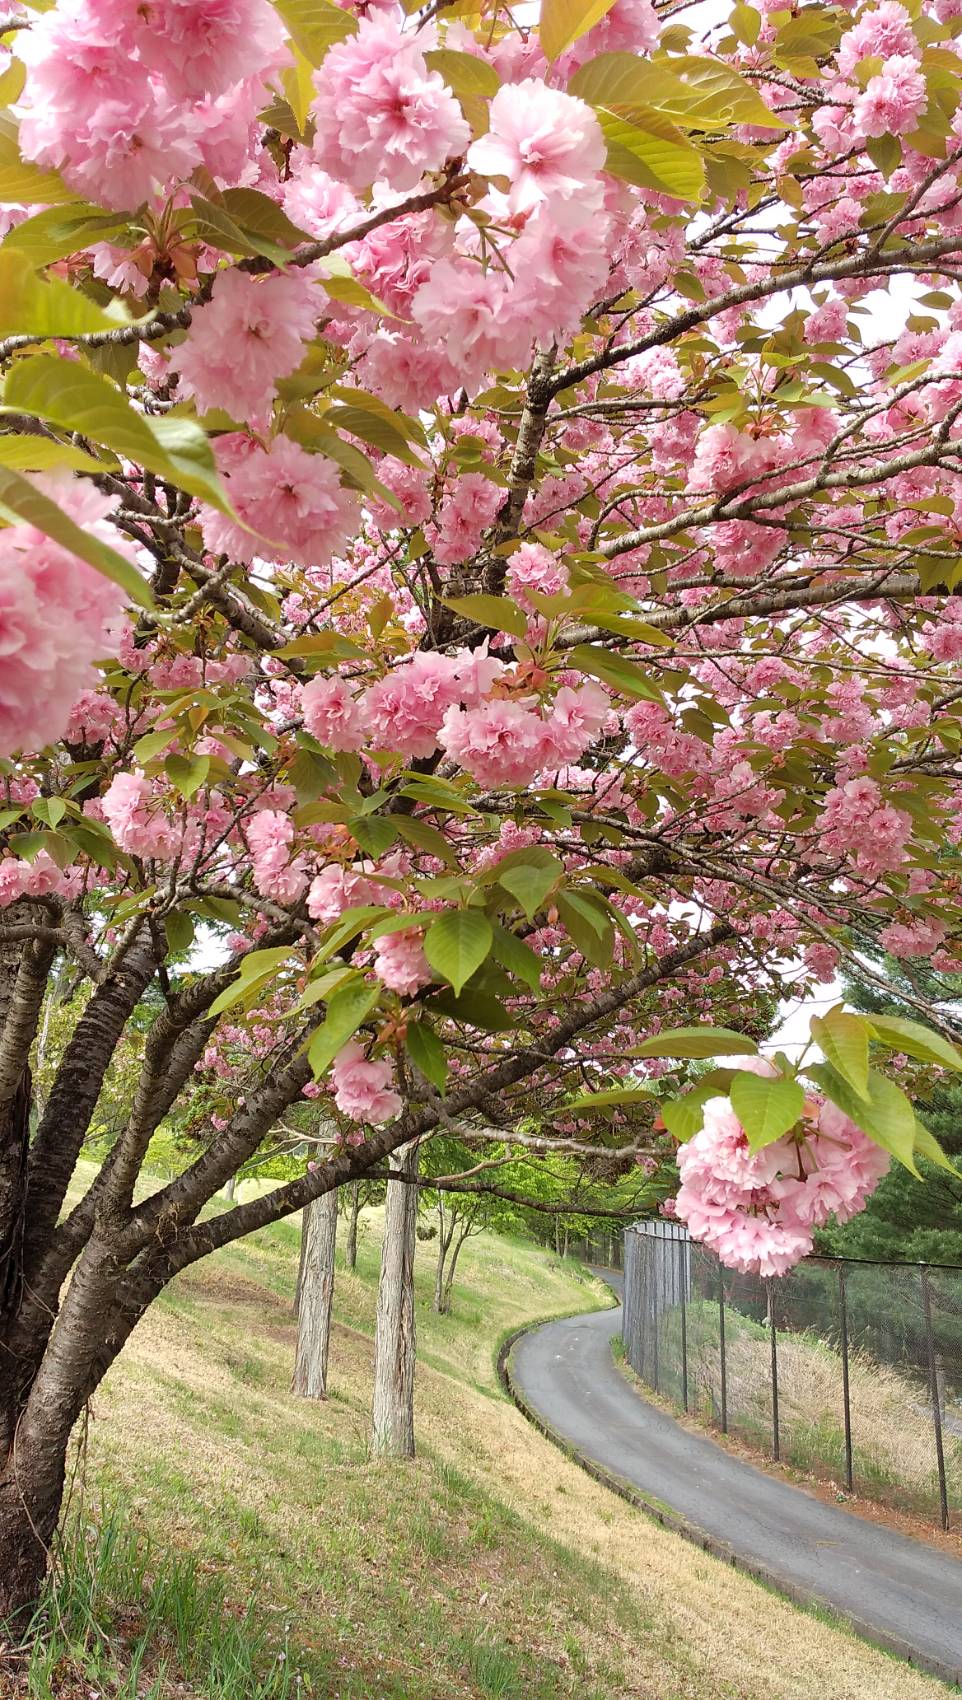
[65,1176,948,1700]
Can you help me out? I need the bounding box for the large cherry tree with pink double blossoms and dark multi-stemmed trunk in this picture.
[0,0,962,1615]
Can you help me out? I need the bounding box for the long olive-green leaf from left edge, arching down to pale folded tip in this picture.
[3,354,231,513]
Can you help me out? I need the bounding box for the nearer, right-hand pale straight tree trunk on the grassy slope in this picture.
[372,1144,418,1459]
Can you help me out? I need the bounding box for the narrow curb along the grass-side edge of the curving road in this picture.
[496,1306,962,1690]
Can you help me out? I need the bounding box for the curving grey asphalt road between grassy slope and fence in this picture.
[508,1277,962,1683]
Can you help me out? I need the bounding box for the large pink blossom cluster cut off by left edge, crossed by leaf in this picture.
[0,473,134,755]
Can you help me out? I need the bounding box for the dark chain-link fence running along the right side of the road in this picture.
[624,1222,962,1528]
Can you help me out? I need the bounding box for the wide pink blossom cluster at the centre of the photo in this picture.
[301,646,610,785]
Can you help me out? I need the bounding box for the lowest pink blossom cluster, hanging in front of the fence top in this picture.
[675,1069,889,1275]
